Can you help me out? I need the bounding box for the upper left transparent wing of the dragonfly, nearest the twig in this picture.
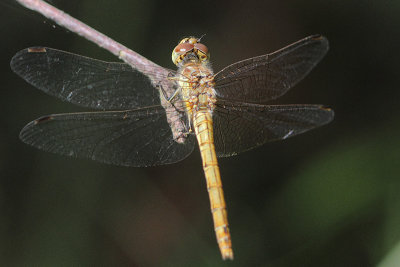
[10,47,176,110]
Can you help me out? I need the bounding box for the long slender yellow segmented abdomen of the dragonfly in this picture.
[193,109,233,259]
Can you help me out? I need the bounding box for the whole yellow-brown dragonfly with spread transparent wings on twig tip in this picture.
[10,35,334,259]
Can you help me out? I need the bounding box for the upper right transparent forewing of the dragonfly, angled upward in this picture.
[215,35,329,103]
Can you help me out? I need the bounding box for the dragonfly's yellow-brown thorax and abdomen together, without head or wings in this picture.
[177,61,233,259]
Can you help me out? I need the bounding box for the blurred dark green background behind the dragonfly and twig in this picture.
[0,0,400,267]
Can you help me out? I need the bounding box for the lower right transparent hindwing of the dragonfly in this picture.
[213,101,334,157]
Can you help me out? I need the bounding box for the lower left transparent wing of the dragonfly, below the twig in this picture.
[20,106,195,167]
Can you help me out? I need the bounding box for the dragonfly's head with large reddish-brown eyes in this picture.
[172,37,210,66]
